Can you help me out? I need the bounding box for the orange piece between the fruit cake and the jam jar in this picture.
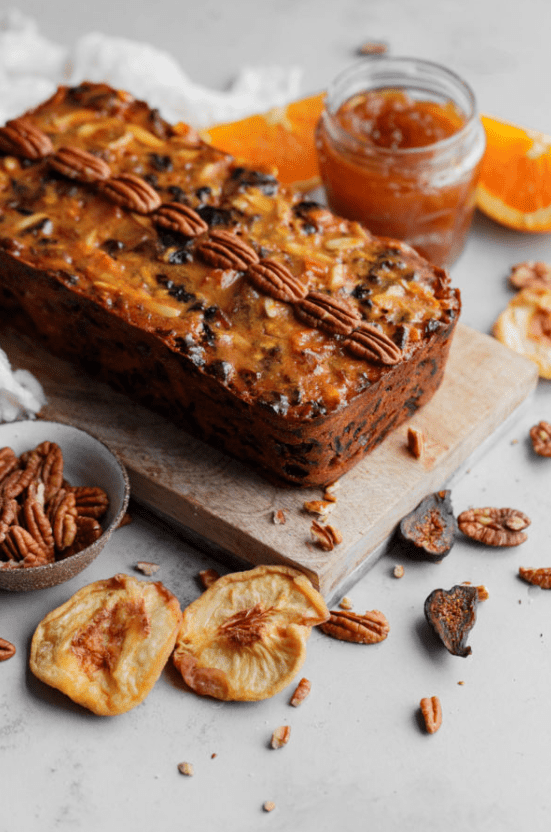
[201,93,325,190]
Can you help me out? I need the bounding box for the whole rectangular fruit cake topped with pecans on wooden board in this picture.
[0,83,460,486]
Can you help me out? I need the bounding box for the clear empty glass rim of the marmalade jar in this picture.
[324,55,482,157]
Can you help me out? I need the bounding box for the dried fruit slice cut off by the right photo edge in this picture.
[493,286,551,379]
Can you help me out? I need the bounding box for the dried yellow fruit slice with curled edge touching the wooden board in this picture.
[174,566,329,701]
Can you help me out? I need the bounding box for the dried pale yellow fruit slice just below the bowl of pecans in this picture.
[30,574,182,716]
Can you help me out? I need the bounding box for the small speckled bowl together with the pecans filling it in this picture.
[0,419,130,591]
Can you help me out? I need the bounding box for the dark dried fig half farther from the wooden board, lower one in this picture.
[425,584,478,656]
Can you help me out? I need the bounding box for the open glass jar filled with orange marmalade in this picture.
[316,56,485,266]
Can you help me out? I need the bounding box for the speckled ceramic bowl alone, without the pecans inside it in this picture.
[0,419,130,591]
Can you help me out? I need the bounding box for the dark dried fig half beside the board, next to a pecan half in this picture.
[398,491,457,561]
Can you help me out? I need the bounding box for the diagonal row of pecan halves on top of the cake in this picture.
[0,118,402,365]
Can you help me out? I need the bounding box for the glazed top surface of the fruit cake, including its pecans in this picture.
[0,84,460,419]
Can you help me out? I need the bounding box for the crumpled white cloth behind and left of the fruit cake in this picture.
[0,9,302,422]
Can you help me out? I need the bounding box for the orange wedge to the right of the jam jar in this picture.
[477,116,551,232]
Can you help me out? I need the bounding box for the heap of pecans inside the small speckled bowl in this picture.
[0,441,109,569]
